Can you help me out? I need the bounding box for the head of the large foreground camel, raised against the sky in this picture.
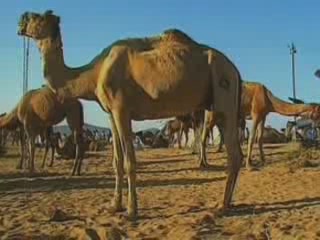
[18,10,60,40]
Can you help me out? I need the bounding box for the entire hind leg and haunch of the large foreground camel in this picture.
[208,52,242,209]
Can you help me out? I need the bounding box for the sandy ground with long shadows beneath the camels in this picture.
[0,145,320,240]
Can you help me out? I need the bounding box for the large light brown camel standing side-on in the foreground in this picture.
[18,11,242,219]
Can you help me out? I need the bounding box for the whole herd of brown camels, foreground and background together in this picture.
[0,11,320,219]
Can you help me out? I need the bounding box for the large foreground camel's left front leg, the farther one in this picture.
[110,115,124,212]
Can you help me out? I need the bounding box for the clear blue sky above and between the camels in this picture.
[0,0,320,129]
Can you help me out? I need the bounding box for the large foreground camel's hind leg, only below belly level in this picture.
[223,113,242,209]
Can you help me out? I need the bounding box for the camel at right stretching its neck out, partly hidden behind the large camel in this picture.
[200,82,320,170]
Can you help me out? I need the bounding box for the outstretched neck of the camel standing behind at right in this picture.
[264,87,305,116]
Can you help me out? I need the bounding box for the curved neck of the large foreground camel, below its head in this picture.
[37,35,98,100]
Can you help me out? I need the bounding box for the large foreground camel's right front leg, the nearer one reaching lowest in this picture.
[113,111,138,220]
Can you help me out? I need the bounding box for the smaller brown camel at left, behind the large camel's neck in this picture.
[0,87,83,175]
